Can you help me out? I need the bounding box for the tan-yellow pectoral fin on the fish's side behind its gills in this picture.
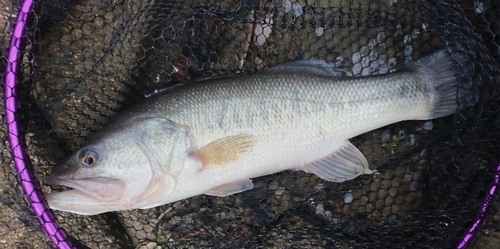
[195,134,255,168]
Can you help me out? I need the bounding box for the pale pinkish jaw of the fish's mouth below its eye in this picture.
[47,176,124,202]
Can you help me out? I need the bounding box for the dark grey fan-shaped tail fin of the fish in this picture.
[415,49,458,119]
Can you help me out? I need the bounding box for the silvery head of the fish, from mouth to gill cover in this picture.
[46,119,189,215]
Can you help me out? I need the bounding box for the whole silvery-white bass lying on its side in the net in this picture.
[46,50,459,215]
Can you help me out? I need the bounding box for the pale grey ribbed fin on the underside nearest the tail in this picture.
[296,141,373,182]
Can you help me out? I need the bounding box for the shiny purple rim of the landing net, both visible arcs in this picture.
[0,0,500,249]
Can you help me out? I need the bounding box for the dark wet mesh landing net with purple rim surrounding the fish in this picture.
[0,0,500,248]
